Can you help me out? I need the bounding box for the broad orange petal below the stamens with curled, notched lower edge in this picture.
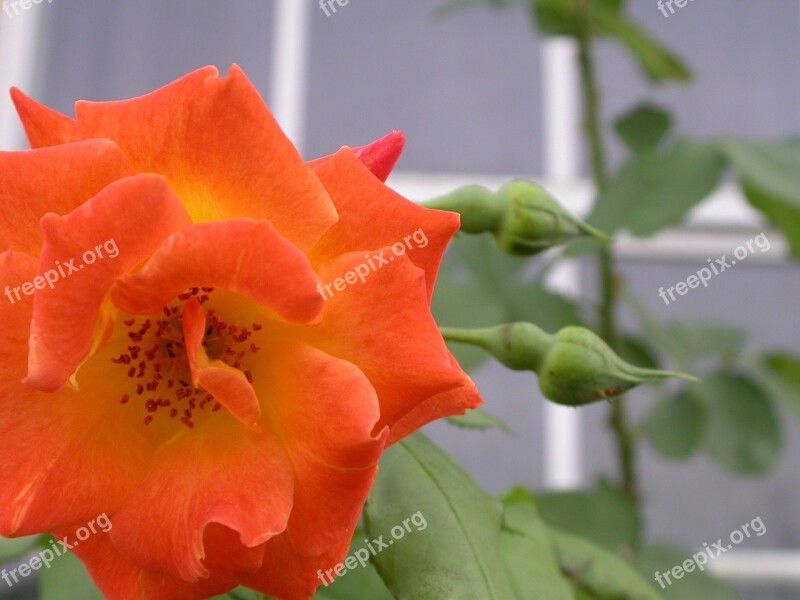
[110,420,294,583]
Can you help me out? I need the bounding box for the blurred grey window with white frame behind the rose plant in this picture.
[0,0,800,600]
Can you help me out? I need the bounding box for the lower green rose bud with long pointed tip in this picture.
[442,323,697,406]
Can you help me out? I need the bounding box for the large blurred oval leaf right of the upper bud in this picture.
[588,141,725,236]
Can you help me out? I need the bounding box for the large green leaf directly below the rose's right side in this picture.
[364,433,514,600]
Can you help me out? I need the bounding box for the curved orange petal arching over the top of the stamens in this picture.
[113,219,323,323]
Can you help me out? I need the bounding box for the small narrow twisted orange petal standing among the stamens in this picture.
[181,298,261,429]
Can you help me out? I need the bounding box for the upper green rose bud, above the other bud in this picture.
[425,181,610,256]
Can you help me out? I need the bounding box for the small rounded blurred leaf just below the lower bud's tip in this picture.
[645,390,707,460]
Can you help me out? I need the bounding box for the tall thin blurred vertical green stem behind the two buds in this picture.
[574,0,639,502]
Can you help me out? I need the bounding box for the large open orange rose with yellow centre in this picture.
[0,66,480,600]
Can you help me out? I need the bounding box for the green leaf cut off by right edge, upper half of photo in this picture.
[721,139,800,257]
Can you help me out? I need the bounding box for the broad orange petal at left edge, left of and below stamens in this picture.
[0,252,150,536]
